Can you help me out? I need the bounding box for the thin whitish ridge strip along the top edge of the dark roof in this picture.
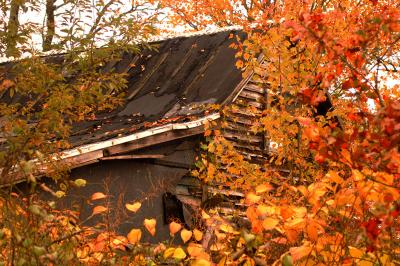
[0,25,243,64]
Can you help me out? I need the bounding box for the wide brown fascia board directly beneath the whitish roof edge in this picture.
[104,126,204,156]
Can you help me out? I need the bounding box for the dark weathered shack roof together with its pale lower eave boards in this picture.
[0,30,253,183]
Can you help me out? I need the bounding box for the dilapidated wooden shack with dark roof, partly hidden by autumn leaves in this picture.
[2,30,269,241]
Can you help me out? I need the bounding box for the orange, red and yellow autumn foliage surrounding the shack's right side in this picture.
[0,0,400,266]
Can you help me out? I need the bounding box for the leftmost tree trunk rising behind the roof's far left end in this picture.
[6,0,21,56]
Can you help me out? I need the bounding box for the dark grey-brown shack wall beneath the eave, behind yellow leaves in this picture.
[25,136,202,243]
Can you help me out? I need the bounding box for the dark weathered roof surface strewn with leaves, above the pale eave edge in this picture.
[71,31,242,146]
